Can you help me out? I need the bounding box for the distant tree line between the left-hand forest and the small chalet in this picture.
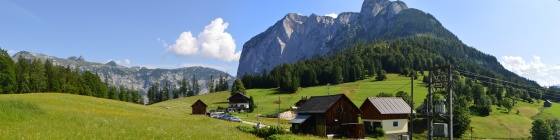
[146,74,229,104]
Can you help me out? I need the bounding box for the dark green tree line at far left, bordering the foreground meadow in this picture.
[0,49,143,104]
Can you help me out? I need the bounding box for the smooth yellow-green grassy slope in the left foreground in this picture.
[0,93,258,139]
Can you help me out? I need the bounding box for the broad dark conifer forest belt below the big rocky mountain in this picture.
[242,36,538,93]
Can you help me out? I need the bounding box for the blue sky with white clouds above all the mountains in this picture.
[0,0,560,85]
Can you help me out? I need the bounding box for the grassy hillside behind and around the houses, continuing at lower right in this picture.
[161,74,560,138]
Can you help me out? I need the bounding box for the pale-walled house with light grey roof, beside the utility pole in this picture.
[360,97,411,134]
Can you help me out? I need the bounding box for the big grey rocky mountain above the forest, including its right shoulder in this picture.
[237,0,457,77]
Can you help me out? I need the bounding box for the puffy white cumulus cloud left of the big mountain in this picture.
[163,18,241,62]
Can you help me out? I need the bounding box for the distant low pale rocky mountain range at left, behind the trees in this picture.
[12,51,234,94]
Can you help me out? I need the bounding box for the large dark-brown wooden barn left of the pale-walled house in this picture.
[290,94,365,138]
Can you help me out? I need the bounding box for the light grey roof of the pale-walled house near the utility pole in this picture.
[367,97,410,114]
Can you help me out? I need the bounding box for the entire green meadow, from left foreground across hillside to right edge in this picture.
[0,74,560,139]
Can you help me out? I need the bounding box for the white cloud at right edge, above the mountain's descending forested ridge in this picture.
[500,56,560,86]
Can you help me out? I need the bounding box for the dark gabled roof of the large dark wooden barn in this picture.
[298,94,362,113]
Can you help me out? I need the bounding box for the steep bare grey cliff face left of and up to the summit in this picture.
[237,0,408,77]
